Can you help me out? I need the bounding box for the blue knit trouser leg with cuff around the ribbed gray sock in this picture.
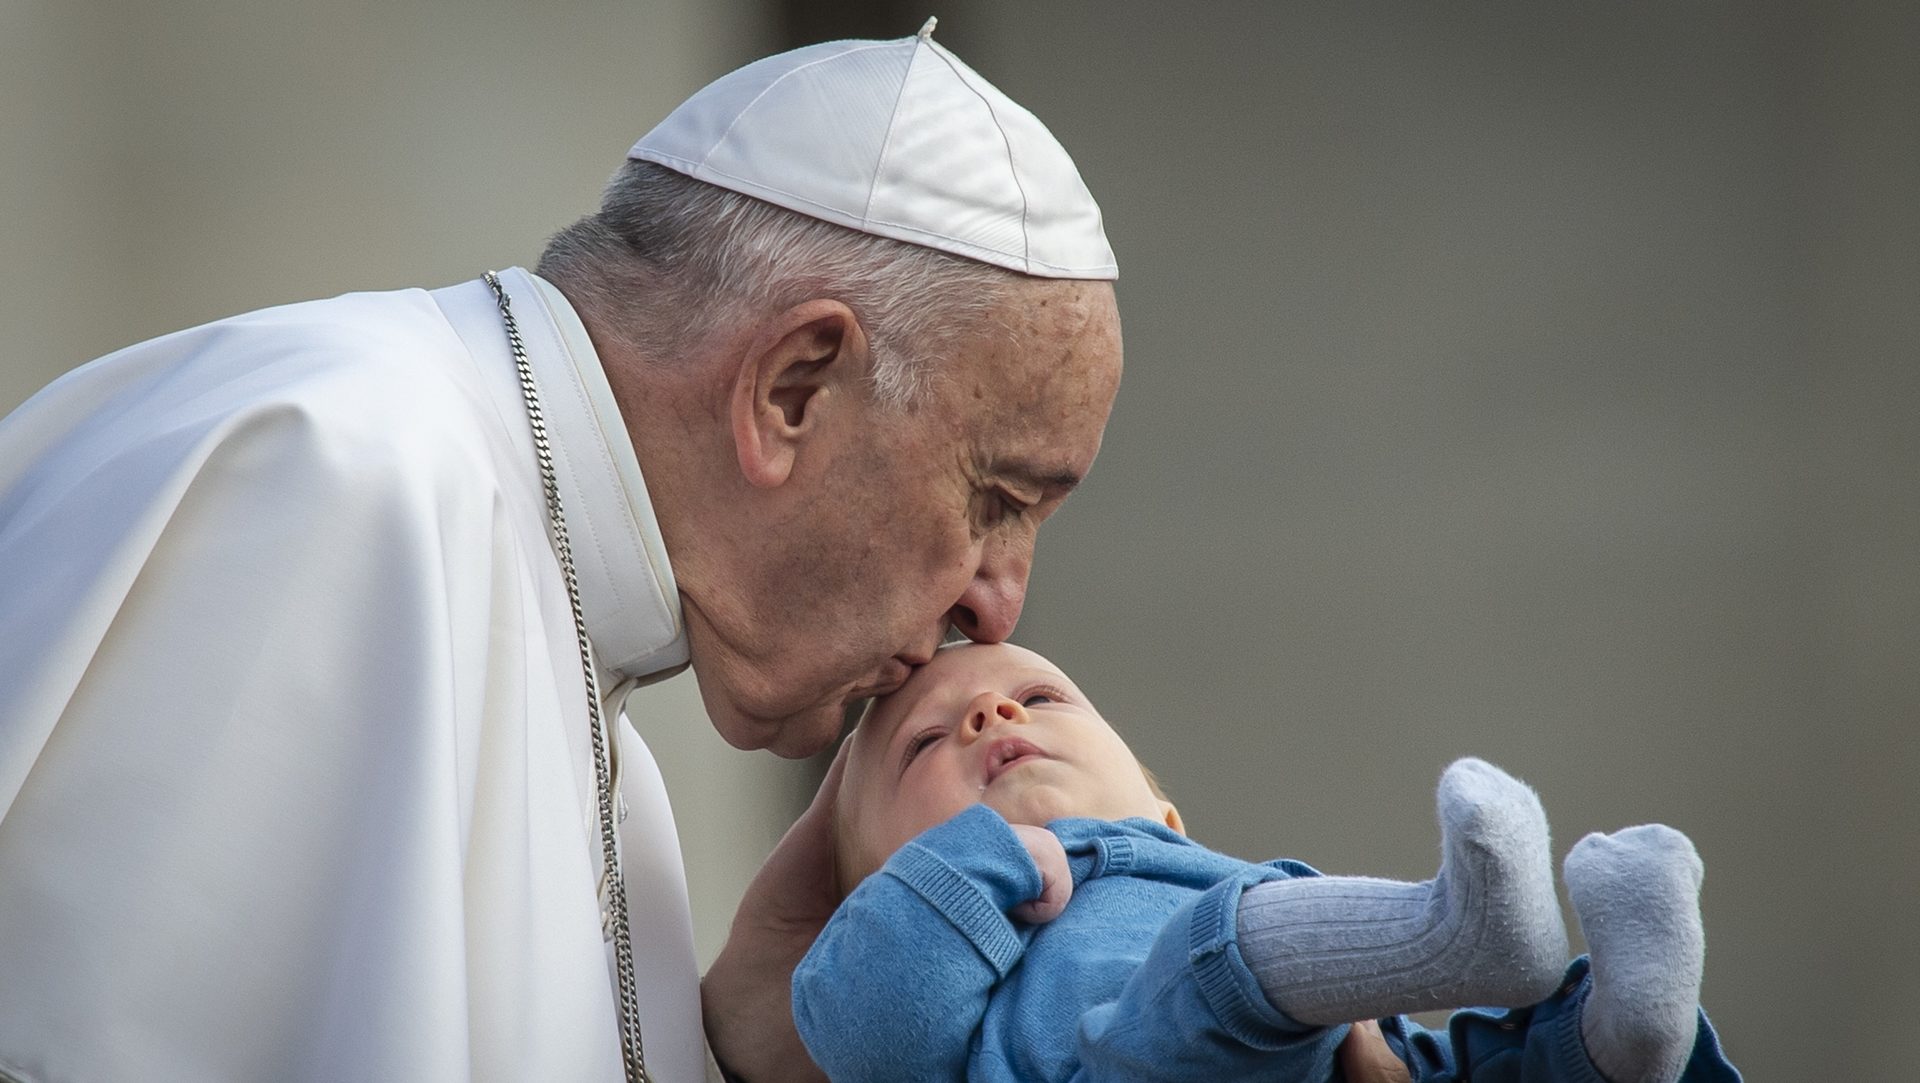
[1075,866,1346,1083]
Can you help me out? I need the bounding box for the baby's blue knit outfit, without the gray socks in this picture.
[793,805,1740,1083]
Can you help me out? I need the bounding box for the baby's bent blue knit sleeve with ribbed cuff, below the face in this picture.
[793,805,1041,1083]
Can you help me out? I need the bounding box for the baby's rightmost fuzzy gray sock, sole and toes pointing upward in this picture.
[1567,824,1707,1083]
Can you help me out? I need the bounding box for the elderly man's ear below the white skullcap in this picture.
[728,300,868,488]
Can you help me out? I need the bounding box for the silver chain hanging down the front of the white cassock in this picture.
[486,271,647,1083]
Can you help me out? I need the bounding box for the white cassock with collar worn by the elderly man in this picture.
[0,269,707,1083]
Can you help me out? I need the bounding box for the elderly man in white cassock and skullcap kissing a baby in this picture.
[0,25,1413,1081]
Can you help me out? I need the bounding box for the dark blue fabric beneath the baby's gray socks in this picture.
[1380,956,1740,1083]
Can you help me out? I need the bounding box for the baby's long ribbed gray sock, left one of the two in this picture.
[1238,758,1567,1025]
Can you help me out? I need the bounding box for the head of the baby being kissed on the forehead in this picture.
[833,643,1181,891]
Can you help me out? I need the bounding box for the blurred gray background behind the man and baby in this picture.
[0,0,1920,1081]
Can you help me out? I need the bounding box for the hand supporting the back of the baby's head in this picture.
[701,743,847,1083]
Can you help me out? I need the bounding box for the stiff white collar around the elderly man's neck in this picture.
[444,267,687,689]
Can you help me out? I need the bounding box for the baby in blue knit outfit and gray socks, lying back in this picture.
[793,643,1740,1083]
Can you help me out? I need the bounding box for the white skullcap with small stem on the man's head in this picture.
[628,19,1119,278]
